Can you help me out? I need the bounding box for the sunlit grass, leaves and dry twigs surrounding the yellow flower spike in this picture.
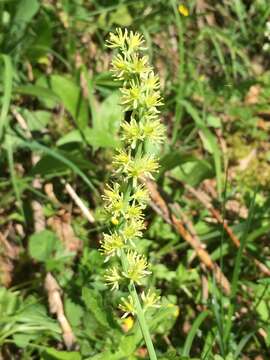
[0,0,270,360]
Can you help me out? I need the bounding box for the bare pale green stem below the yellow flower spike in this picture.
[121,251,157,360]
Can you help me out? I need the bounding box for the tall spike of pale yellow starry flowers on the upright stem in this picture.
[101,29,165,317]
